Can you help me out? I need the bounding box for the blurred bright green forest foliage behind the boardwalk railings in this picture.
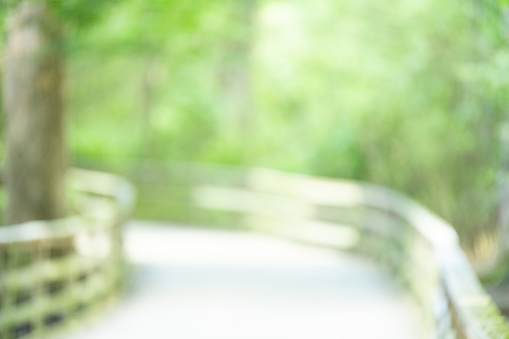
[0,0,509,266]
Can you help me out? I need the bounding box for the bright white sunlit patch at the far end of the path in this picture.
[125,226,350,266]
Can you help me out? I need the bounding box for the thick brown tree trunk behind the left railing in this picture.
[3,1,66,224]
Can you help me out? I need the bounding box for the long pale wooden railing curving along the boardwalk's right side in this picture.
[124,164,509,339]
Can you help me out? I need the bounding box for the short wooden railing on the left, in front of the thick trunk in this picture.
[0,170,134,339]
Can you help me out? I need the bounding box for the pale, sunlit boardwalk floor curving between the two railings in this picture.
[62,222,423,339]
